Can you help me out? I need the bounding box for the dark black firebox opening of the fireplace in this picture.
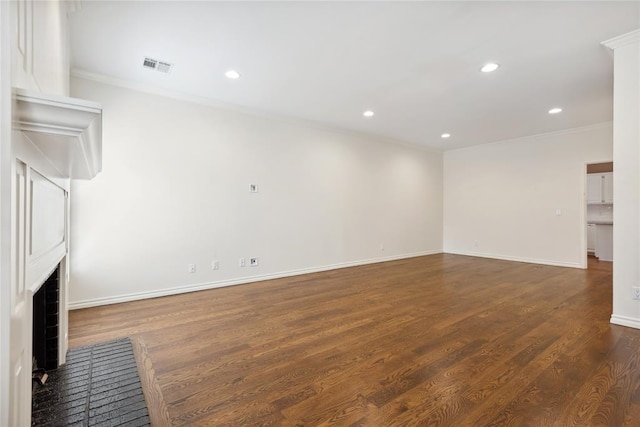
[32,266,60,382]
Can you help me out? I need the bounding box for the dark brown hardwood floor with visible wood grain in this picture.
[70,255,640,426]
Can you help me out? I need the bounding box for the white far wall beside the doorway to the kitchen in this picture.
[444,124,613,267]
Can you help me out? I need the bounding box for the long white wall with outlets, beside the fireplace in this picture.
[70,78,442,307]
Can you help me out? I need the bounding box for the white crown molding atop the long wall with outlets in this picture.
[71,68,443,154]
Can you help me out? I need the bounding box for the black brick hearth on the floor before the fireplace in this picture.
[31,338,150,427]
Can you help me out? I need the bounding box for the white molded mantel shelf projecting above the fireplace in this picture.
[13,89,102,179]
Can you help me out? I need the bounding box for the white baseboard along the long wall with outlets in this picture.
[69,250,442,310]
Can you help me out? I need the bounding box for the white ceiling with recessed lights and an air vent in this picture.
[70,1,640,150]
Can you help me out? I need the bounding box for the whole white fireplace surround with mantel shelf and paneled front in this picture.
[8,88,102,426]
